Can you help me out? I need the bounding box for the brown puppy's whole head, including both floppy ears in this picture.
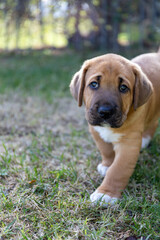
[70,54,152,128]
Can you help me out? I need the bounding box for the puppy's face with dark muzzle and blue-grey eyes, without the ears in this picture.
[83,56,134,128]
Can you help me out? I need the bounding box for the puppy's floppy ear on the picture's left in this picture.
[70,61,88,107]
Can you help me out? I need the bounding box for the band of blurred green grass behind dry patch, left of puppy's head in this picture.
[0,50,85,100]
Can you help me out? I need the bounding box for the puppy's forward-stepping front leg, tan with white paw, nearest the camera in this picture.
[90,133,142,207]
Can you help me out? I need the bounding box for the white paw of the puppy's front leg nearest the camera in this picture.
[90,190,118,208]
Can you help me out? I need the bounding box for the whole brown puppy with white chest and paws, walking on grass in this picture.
[70,52,160,206]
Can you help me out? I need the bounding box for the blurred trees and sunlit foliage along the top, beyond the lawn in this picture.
[0,0,160,52]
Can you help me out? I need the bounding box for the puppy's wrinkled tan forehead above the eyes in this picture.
[86,56,134,81]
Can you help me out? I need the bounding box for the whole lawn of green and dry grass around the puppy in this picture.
[0,49,160,240]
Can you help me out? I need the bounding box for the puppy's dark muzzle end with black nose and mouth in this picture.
[86,106,127,128]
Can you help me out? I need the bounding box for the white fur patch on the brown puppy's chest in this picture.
[94,126,123,143]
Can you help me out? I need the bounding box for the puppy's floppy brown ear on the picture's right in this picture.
[133,64,153,110]
